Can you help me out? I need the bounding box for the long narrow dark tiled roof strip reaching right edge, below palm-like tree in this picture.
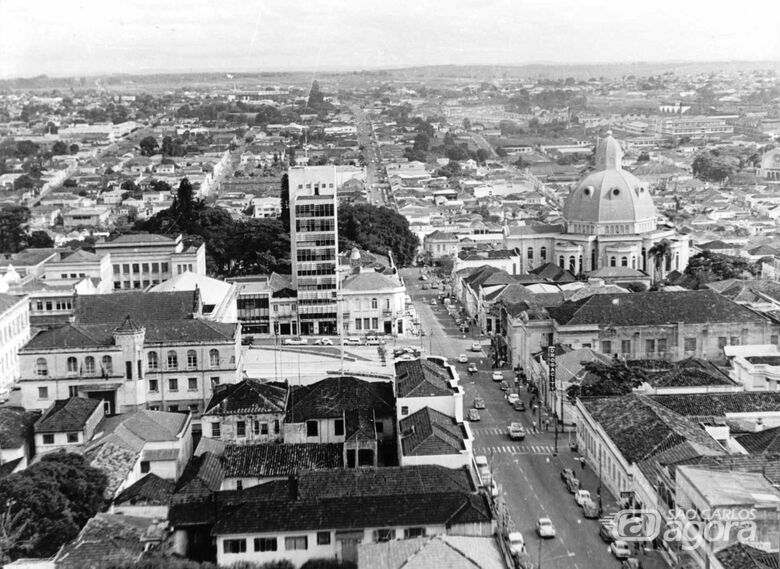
[650,391,780,417]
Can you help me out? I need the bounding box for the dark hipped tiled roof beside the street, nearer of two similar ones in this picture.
[399,407,466,456]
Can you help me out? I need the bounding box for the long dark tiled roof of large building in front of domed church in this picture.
[550,290,765,326]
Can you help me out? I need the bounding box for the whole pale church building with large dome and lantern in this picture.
[504,132,690,281]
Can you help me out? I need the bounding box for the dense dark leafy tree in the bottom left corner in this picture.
[0,452,108,562]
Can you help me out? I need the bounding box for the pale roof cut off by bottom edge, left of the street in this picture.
[358,535,506,569]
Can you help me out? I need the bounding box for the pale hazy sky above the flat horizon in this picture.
[0,0,780,78]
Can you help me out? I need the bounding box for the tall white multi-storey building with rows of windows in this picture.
[288,166,339,335]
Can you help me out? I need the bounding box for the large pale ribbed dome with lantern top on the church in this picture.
[563,131,655,232]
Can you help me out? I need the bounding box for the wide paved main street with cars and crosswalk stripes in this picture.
[402,269,620,569]
